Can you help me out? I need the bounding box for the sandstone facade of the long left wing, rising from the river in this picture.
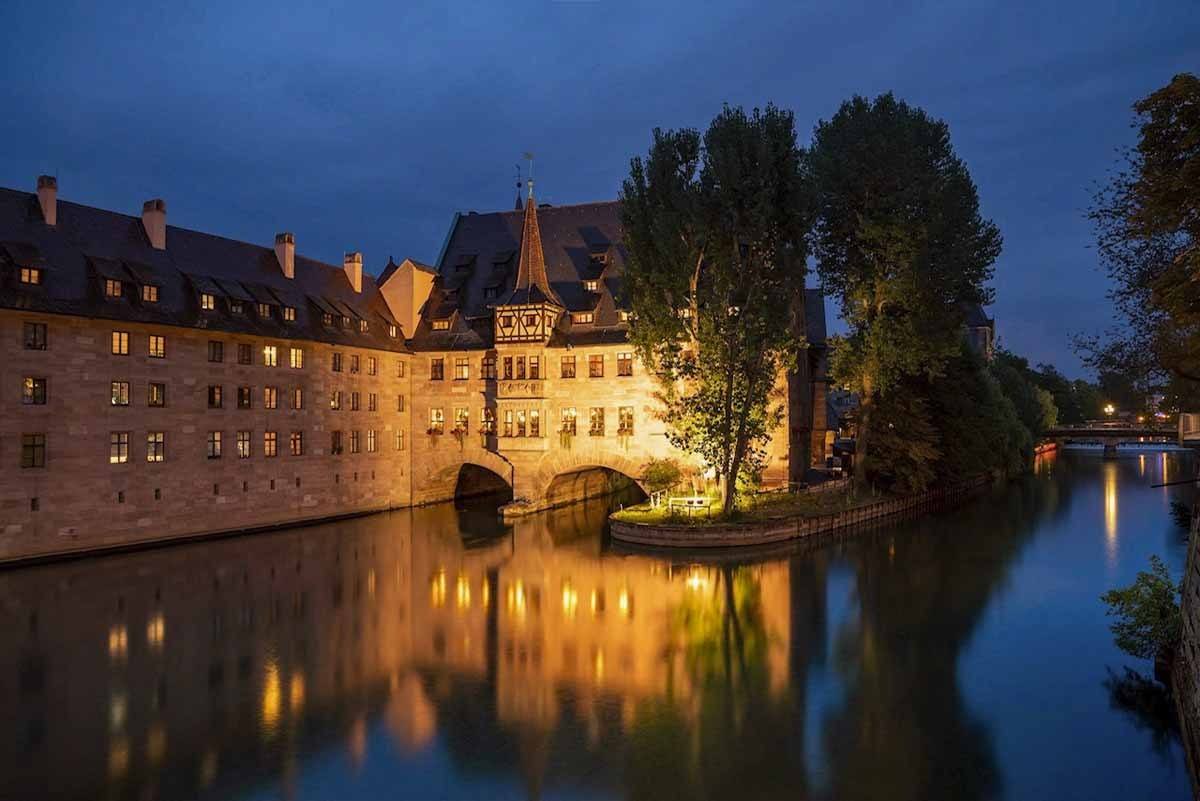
[0,312,412,561]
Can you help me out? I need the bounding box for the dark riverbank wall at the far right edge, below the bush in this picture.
[1172,505,1200,799]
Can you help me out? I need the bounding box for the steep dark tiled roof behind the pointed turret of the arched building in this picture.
[410,200,826,350]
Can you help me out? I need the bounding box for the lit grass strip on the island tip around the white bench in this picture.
[612,488,878,526]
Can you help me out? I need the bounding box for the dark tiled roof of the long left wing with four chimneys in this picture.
[0,188,404,350]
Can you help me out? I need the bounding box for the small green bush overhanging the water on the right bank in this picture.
[1100,556,1183,660]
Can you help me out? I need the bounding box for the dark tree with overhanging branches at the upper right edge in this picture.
[1078,74,1200,398]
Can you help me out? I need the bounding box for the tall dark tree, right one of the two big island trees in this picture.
[808,94,1001,481]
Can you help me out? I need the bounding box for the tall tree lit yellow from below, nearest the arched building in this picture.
[620,106,808,512]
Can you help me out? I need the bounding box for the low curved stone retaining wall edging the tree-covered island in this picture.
[610,476,991,548]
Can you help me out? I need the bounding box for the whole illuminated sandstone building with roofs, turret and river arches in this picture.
[0,176,826,561]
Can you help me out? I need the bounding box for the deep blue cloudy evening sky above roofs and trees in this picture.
[0,0,1200,375]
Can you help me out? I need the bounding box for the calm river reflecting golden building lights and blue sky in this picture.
[0,451,1194,801]
